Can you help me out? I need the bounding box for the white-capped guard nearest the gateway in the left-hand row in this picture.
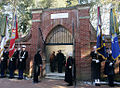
[18,45,28,79]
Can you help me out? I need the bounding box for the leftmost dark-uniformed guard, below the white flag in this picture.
[1,47,9,78]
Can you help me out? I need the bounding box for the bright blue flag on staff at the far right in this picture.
[110,9,119,60]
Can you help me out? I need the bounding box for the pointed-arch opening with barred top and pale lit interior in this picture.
[46,25,73,73]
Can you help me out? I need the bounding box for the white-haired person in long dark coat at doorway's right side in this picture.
[65,54,73,86]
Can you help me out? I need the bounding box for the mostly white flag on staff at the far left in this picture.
[0,16,10,57]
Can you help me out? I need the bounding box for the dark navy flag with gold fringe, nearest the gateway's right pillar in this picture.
[97,7,107,59]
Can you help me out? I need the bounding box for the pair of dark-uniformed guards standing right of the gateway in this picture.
[90,46,115,86]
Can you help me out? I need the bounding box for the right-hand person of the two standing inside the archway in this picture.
[57,50,65,73]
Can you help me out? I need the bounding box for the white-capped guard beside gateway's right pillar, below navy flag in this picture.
[90,46,102,86]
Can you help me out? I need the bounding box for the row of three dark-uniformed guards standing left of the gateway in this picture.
[0,45,28,79]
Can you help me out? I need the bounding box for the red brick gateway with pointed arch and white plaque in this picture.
[28,5,92,80]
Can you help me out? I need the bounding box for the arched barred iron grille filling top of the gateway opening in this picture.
[46,25,73,45]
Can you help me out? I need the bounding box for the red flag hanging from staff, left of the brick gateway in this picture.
[9,14,18,57]
